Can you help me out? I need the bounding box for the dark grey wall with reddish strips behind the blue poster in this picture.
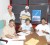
[12,0,48,23]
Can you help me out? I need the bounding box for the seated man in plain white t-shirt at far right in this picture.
[35,18,50,42]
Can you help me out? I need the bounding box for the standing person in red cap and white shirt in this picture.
[3,5,15,25]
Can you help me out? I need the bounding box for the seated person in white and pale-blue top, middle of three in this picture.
[19,19,33,34]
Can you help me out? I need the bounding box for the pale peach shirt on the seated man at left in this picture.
[2,26,15,38]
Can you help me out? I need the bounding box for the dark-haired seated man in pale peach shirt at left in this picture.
[3,19,16,39]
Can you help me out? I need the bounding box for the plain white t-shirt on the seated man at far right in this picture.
[35,24,50,36]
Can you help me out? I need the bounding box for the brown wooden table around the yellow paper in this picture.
[25,33,47,45]
